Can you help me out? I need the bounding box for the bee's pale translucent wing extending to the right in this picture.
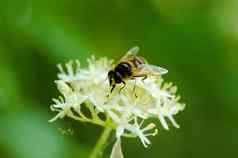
[139,64,168,75]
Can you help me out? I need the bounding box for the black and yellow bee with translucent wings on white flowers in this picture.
[108,46,168,93]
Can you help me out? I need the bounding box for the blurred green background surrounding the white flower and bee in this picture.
[0,0,238,158]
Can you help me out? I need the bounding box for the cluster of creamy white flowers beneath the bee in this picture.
[50,56,185,147]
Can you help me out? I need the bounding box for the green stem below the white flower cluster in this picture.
[89,126,112,158]
